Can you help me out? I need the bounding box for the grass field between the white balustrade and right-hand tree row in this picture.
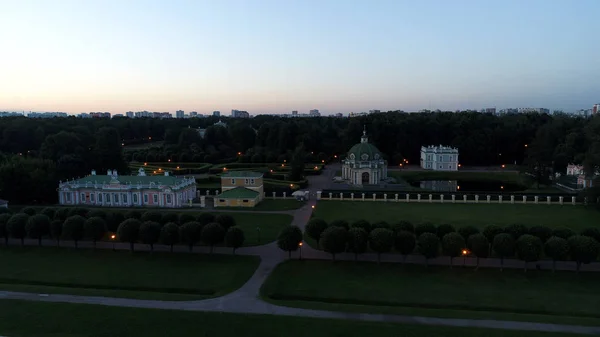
[313,200,600,231]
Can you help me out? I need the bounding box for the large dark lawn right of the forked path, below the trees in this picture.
[261,260,600,325]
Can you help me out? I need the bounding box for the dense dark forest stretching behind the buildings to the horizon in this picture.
[0,112,600,203]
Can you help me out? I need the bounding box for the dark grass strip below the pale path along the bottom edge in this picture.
[0,300,579,337]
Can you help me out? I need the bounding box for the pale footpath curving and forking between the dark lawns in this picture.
[0,167,600,335]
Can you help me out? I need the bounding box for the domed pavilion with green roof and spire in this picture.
[342,130,387,186]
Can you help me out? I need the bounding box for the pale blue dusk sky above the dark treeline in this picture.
[0,0,600,114]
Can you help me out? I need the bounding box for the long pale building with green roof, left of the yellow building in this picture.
[58,168,196,208]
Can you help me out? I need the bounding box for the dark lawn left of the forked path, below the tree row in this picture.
[0,247,260,300]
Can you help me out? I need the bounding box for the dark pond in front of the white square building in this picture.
[410,180,527,192]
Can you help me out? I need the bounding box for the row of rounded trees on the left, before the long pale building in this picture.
[0,207,245,253]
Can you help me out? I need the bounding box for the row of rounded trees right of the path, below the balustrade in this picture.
[277,218,600,271]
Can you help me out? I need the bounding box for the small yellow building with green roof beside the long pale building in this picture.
[215,171,265,207]
